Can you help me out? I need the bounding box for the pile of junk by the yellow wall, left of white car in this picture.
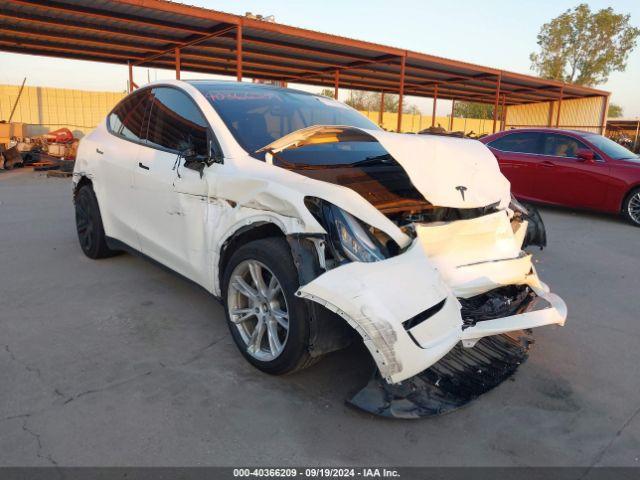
[0,122,79,174]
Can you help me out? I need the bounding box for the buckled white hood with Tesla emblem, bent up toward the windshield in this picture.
[258,125,510,208]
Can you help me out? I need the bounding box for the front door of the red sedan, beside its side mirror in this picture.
[539,133,610,209]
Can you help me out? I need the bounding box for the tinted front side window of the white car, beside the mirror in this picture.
[147,87,208,155]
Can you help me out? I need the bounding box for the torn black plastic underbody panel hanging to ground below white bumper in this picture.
[347,330,533,419]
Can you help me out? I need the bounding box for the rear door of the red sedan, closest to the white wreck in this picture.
[487,131,542,200]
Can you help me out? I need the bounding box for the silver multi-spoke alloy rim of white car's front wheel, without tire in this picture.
[227,260,289,362]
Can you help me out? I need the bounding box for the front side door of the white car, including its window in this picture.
[134,87,211,285]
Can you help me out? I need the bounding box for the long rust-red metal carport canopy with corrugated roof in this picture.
[0,0,609,130]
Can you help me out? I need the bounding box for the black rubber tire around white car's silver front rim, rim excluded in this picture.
[222,237,315,375]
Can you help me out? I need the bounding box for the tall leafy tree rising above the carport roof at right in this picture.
[529,3,640,86]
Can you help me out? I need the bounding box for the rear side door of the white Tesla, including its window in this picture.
[87,89,151,250]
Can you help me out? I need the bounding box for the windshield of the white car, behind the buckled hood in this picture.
[193,82,378,159]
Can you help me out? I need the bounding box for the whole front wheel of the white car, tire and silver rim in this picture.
[222,237,312,375]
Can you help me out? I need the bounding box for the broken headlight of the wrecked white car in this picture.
[305,197,396,263]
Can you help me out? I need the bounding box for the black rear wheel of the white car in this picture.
[74,185,118,260]
